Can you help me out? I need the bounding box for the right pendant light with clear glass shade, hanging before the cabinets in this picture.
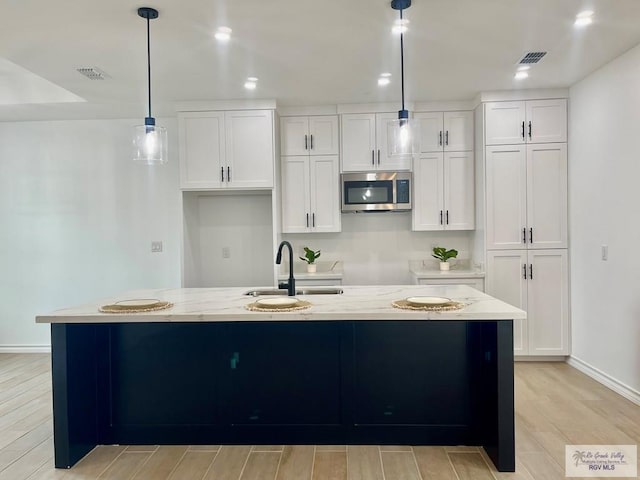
[387,0,419,155]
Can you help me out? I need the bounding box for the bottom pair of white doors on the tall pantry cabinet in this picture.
[486,249,569,356]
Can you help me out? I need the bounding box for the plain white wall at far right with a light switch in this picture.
[569,46,640,394]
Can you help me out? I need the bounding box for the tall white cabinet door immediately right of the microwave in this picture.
[411,153,444,231]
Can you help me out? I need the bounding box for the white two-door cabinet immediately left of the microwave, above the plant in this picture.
[282,155,341,233]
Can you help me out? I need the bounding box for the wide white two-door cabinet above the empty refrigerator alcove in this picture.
[178,110,274,190]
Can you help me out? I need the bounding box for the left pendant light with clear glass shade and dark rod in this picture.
[133,7,168,165]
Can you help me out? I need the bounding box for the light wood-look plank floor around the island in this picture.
[0,354,640,480]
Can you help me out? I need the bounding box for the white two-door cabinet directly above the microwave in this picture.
[341,113,411,172]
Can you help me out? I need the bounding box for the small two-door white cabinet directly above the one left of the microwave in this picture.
[280,115,340,155]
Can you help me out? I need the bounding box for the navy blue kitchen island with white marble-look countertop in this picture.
[37,285,525,471]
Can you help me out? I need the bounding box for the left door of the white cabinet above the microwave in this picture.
[340,113,376,172]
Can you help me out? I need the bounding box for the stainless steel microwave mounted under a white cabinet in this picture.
[341,172,411,212]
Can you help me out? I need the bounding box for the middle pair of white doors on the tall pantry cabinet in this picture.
[486,143,568,249]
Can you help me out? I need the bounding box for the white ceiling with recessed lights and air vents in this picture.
[0,0,640,121]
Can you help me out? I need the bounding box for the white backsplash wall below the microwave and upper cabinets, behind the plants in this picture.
[282,212,471,285]
